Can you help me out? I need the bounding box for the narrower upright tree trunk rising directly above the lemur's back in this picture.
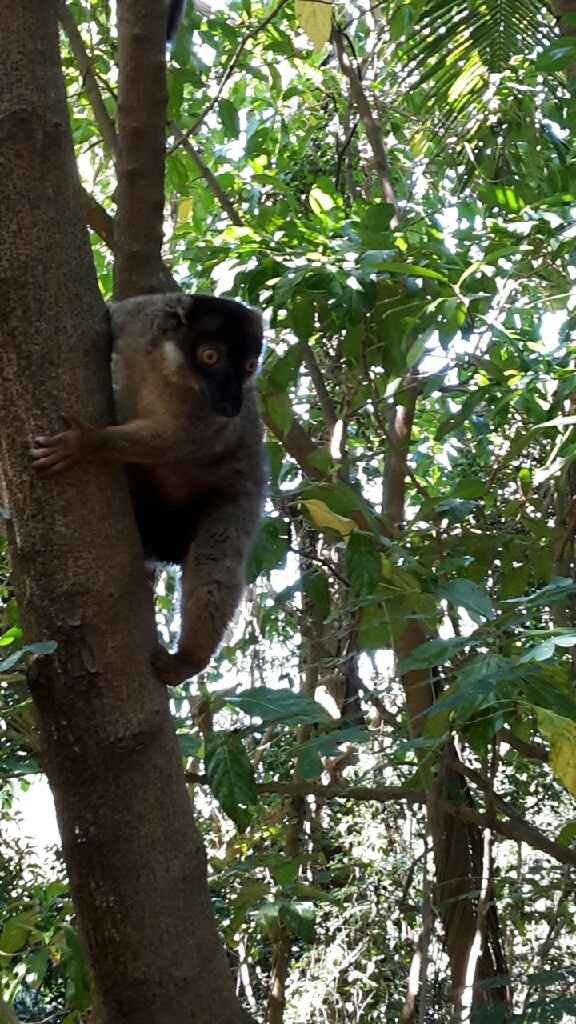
[114,0,167,299]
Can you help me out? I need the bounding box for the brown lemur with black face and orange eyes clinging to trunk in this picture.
[32,294,264,685]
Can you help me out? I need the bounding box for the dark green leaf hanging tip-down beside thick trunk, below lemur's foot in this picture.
[204,732,254,829]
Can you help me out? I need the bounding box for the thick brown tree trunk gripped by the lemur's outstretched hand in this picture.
[0,0,241,1024]
